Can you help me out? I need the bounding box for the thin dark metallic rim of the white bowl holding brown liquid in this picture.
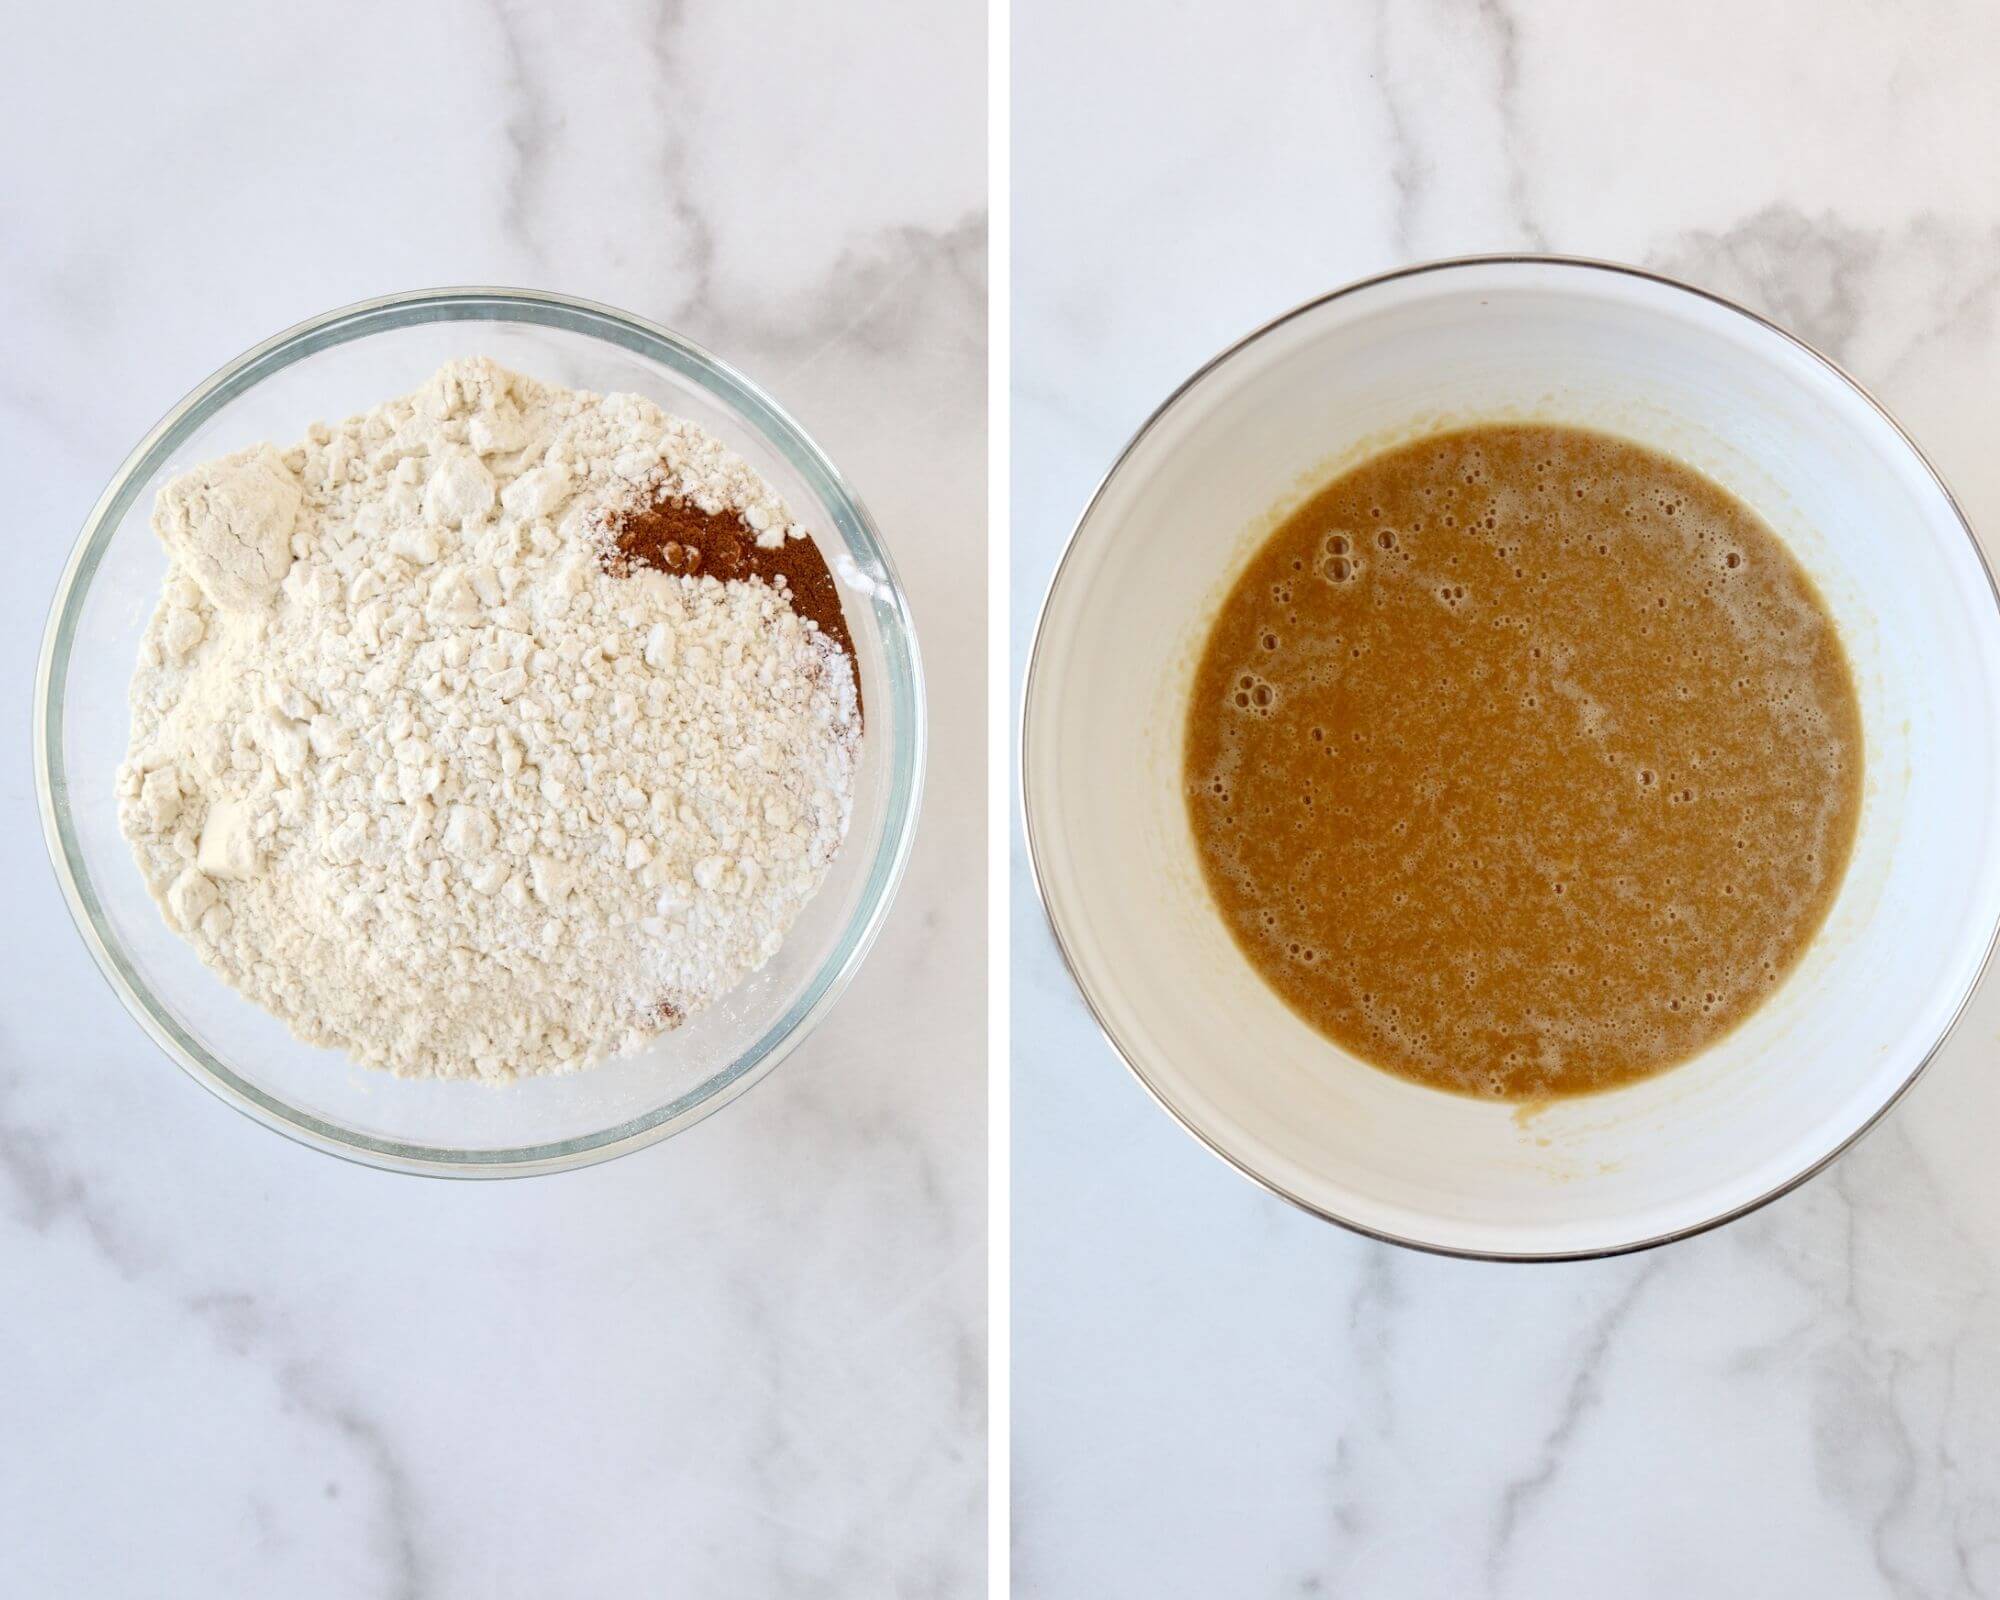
[1014,252,2000,1264]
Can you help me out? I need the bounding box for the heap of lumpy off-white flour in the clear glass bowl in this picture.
[118,360,860,1078]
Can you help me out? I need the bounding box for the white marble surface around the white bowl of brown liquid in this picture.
[1012,0,2000,1600]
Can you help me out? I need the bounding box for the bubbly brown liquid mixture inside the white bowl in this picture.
[1184,426,1862,1100]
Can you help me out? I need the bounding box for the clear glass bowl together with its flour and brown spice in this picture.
[36,290,924,1176]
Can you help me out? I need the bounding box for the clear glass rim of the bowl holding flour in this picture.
[32,284,928,1178]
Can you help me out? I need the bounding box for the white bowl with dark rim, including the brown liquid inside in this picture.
[1022,258,2000,1258]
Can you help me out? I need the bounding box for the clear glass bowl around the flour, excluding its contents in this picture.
[34,288,924,1176]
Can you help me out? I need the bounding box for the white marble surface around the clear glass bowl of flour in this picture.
[0,0,986,1600]
